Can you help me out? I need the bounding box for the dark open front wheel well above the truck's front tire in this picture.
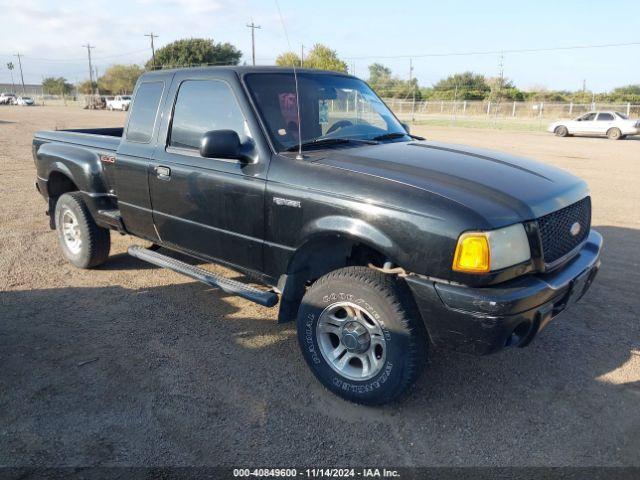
[278,235,390,322]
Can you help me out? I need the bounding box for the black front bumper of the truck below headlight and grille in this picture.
[406,230,602,355]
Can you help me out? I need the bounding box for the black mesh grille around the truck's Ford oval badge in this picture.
[538,197,591,265]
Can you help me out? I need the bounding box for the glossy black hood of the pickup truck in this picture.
[316,141,588,227]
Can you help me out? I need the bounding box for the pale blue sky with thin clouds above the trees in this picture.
[0,0,640,92]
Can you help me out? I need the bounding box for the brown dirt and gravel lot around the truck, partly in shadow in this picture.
[0,107,640,466]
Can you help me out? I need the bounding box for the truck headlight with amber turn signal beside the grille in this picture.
[453,223,531,273]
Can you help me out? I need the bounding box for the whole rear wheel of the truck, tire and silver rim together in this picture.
[55,192,111,268]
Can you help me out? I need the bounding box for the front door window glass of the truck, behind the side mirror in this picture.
[169,80,249,150]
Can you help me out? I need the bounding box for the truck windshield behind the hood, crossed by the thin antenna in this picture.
[245,72,409,151]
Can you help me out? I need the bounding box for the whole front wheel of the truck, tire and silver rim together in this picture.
[298,267,427,405]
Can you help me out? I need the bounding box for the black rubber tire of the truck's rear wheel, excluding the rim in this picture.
[55,192,111,268]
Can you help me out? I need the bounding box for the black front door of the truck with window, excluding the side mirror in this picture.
[149,69,271,272]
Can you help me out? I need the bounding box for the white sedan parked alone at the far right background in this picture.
[547,111,640,140]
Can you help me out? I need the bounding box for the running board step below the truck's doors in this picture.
[128,245,278,307]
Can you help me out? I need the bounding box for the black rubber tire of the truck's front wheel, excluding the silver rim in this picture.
[297,267,428,405]
